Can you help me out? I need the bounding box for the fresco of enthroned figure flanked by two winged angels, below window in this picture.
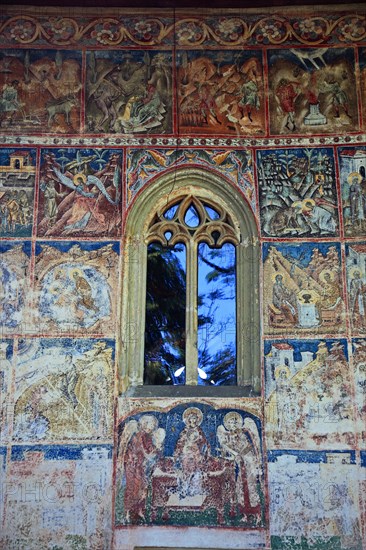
[116,403,264,528]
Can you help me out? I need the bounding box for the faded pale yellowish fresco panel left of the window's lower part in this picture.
[13,338,114,442]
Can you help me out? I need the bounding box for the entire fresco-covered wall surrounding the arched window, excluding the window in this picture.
[0,5,366,550]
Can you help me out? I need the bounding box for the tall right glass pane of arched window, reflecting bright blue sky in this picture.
[198,243,236,386]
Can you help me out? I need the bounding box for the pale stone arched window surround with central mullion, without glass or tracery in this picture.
[118,167,261,397]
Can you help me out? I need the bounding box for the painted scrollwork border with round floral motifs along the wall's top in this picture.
[0,9,366,48]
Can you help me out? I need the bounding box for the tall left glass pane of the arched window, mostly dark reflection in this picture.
[144,242,186,385]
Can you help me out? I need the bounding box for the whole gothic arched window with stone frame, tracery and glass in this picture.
[121,168,260,395]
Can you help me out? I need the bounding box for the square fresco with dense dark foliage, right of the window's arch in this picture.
[257,148,339,238]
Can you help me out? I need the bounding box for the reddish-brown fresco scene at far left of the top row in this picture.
[0,49,82,134]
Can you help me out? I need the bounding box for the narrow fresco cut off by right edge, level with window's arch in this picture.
[338,146,366,237]
